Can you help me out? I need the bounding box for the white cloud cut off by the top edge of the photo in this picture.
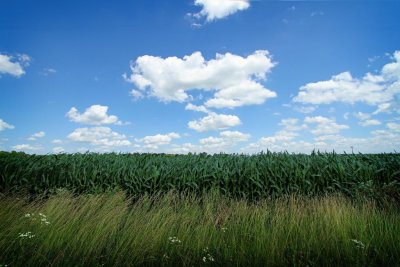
[192,0,250,21]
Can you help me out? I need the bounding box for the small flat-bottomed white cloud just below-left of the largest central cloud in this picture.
[66,105,122,125]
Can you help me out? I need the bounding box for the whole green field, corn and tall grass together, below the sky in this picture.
[0,152,400,266]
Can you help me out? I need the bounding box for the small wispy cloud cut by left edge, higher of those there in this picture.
[0,54,31,77]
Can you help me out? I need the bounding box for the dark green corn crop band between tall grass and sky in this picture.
[0,152,400,202]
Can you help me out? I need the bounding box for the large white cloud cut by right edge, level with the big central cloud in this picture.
[293,51,400,114]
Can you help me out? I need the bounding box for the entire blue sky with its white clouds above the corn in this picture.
[0,0,400,154]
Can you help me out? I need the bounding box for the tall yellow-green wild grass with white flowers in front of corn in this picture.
[0,191,400,266]
